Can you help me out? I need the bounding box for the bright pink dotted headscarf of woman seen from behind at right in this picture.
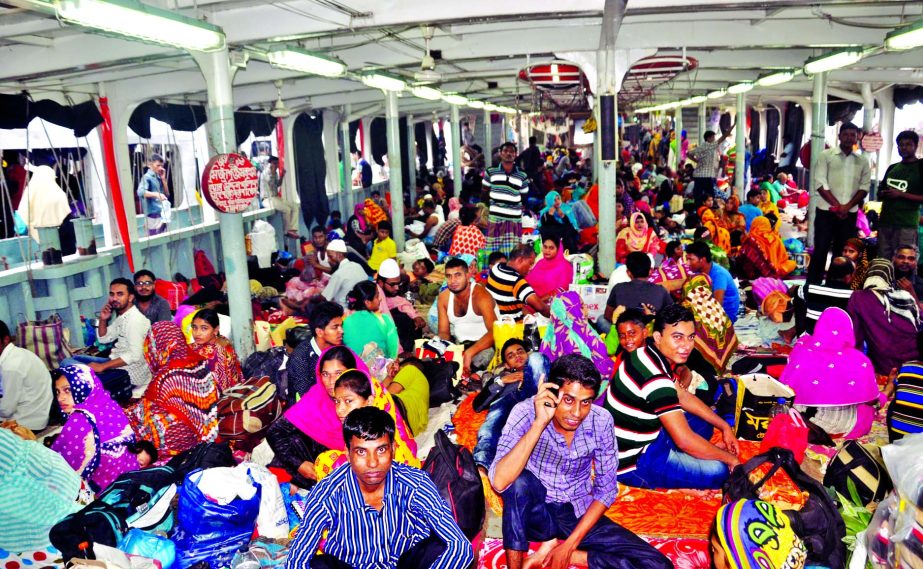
[779,307,878,407]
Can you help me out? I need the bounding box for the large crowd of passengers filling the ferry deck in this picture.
[0,123,923,569]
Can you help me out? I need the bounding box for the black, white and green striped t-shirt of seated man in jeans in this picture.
[605,345,682,474]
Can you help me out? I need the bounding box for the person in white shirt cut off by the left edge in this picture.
[0,320,53,431]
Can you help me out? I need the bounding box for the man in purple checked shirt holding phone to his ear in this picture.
[489,354,673,569]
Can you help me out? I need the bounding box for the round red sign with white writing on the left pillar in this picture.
[202,154,260,213]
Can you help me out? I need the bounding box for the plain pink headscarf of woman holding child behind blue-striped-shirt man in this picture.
[285,346,371,450]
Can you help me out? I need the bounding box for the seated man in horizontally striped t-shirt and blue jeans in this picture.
[605,304,740,489]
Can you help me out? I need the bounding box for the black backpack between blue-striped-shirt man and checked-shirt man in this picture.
[423,430,486,540]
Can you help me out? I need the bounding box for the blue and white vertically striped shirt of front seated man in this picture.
[286,462,474,569]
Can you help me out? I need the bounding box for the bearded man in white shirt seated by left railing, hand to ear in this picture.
[61,277,151,403]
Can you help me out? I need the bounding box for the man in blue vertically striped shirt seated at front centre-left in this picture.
[286,407,474,569]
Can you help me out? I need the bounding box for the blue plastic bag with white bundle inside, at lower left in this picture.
[172,468,260,569]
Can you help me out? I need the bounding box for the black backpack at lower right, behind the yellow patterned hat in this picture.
[724,447,846,569]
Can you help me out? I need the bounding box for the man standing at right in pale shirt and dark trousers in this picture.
[808,122,872,284]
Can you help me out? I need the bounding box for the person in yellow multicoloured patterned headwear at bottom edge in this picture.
[709,500,808,569]
